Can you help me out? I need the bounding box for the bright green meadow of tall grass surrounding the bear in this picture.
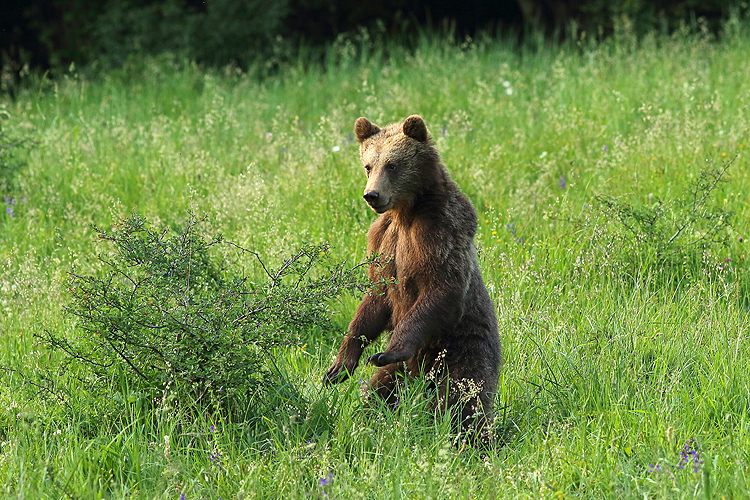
[0,20,750,500]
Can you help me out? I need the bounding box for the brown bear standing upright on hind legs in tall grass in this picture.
[323,116,501,441]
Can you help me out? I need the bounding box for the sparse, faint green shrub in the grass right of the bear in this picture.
[553,157,736,283]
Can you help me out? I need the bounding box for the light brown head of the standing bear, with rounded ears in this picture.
[354,115,439,214]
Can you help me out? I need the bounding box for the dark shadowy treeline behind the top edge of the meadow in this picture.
[0,0,747,78]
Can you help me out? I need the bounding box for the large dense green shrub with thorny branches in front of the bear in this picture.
[44,212,366,418]
